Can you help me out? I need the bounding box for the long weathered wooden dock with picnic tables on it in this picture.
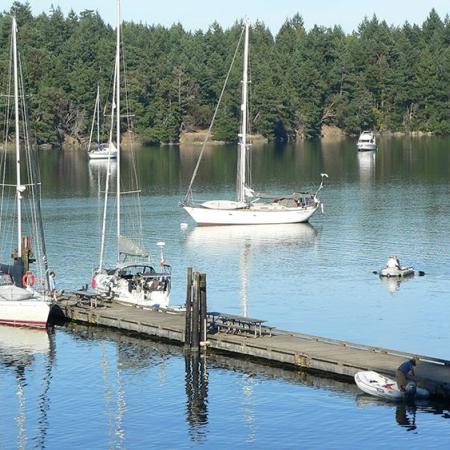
[59,295,450,399]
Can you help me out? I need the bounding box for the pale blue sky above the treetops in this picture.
[6,0,450,33]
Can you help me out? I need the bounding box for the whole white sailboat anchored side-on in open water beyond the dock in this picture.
[181,23,328,225]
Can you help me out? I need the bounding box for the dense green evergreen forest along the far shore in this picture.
[0,2,450,145]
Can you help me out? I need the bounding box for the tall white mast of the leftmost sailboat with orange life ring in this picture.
[12,17,22,258]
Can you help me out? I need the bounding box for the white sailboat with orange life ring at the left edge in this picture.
[0,17,51,328]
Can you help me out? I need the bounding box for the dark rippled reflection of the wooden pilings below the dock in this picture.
[184,352,208,442]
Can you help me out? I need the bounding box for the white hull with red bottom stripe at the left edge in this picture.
[0,300,50,328]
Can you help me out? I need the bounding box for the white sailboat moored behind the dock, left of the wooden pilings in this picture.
[92,0,171,307]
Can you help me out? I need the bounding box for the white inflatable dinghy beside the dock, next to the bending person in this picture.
[355,370,430,401]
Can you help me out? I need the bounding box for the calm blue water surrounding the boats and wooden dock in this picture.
[0,138,450,449]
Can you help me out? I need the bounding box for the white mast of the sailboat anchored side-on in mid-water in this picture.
[237,22,250,202]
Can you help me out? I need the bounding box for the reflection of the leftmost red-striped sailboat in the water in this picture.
[0,325,55,449]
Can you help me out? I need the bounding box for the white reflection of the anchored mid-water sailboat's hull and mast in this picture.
[186,223,317,317]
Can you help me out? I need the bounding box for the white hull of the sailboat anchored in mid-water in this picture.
[184,203,319,225]
